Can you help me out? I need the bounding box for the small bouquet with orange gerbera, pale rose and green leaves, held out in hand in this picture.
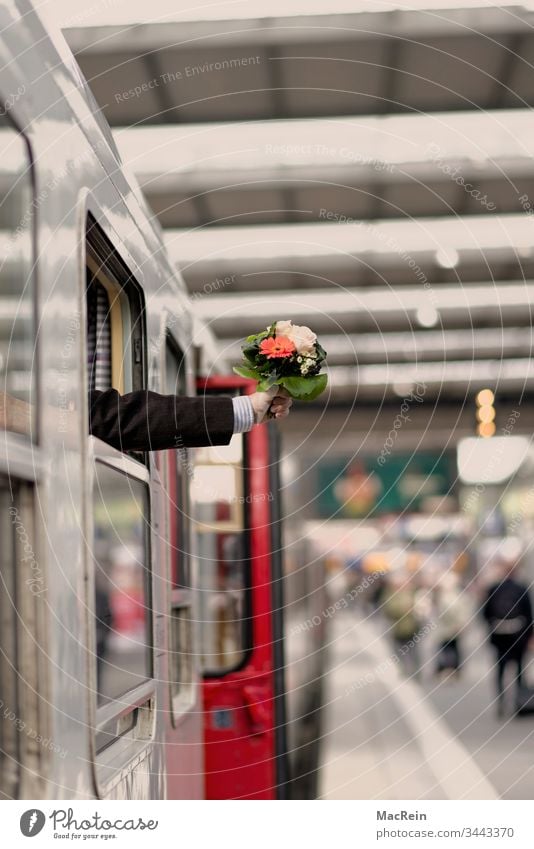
[234,321,328,401]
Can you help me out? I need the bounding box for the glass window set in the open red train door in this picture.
[192,434,250,674]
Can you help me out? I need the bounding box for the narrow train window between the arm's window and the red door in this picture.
[165,336,195,721]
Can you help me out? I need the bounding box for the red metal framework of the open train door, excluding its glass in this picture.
[199,377,276,799]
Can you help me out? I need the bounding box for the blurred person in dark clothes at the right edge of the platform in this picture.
[482,563,533,717]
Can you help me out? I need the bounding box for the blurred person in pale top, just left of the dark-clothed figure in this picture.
[434,572,471,677]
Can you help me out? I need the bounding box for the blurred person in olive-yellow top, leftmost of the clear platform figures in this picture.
[382,575,426,678]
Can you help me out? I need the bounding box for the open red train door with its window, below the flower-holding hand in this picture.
[196,377,287,799]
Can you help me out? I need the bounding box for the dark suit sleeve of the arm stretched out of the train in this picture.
[89,389,234,451]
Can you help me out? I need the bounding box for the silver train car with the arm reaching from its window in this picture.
[0,0,321,800]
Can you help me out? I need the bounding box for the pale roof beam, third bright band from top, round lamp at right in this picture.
[165,210,534,276]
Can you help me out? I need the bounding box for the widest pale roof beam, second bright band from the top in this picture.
[114,109,534,193]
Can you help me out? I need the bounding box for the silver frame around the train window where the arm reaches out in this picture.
[79,202,157,784]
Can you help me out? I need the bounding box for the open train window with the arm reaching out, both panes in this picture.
[86,215,155,760]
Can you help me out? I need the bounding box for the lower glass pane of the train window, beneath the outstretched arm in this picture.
[93,462,152,705]
